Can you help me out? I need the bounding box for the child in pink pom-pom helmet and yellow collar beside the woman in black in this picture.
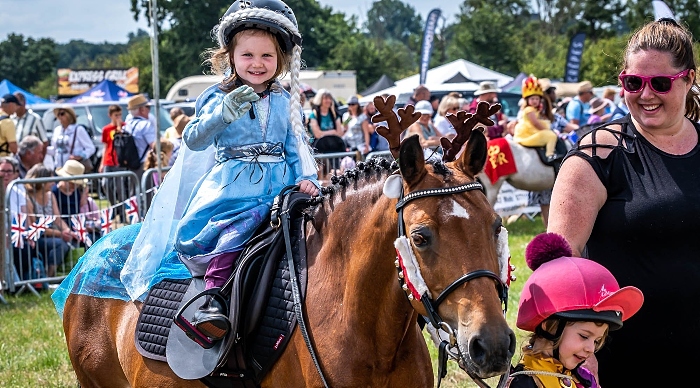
[508,233,644,388]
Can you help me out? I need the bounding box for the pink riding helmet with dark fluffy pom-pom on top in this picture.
[516,233,644,332]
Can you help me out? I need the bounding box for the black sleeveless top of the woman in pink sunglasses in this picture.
[567,115,700,387]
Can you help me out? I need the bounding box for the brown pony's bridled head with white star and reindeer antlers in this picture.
[375,95,515,378]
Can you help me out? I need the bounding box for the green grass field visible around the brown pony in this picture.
[0,218,544,388]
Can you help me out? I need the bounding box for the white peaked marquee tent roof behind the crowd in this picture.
[360,59,513,103]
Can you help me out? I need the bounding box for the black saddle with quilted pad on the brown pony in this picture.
[135,187,315,388]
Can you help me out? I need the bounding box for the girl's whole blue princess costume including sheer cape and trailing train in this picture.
[52,84,318,315]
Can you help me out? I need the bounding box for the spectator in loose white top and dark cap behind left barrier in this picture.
[51,105,96,170]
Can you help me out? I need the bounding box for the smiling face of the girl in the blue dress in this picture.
[233,31,277,93]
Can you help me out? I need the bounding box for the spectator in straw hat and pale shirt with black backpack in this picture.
[123,94,156,181]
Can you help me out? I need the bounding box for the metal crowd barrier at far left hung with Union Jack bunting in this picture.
[0,171,145,295]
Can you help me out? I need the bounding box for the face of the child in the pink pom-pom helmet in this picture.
[559,322,608,370]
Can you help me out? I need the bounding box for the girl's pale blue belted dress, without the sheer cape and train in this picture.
[175,83,318,276]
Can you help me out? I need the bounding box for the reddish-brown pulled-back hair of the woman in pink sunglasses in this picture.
[622,18,700,122]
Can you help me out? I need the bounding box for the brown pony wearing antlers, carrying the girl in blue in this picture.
[63,95,515,387]
